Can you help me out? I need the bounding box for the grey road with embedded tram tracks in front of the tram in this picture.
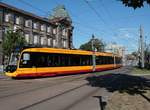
[0,67,139,110]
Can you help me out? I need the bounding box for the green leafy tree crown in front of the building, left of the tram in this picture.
[2,31,26,56]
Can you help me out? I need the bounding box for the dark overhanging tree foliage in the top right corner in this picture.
[119,0,150,9]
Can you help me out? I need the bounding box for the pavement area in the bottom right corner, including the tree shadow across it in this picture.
[106,69,150,110]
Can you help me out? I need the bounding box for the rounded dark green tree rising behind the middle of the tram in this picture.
[79,38,105,52]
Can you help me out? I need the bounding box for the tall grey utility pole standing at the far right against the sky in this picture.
[139,26,145,68]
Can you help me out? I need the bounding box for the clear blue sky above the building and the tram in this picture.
[1,0,150,53]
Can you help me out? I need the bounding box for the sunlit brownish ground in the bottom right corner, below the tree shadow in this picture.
[106,90,150,110]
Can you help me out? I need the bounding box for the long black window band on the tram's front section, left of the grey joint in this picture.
[19,52,92,68]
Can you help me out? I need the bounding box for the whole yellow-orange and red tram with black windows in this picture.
[6,48,122,77]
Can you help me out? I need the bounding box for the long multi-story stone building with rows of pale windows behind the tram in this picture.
[0,2,73,65]
